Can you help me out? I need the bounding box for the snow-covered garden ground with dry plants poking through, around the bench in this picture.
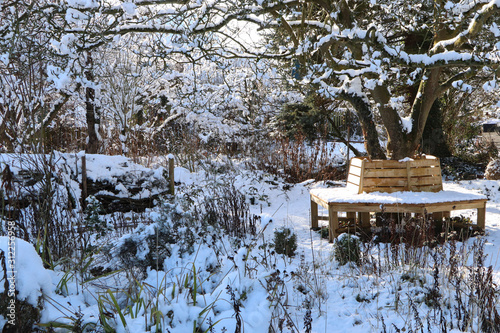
[0,154,500,333]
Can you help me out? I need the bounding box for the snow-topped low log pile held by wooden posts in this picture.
[0,153,171,214]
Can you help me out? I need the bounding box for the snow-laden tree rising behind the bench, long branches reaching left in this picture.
[54,0,500,159]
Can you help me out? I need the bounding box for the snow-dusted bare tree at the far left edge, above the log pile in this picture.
[0,1,76,151]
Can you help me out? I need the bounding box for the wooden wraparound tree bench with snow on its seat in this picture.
[310,156,487,241]
